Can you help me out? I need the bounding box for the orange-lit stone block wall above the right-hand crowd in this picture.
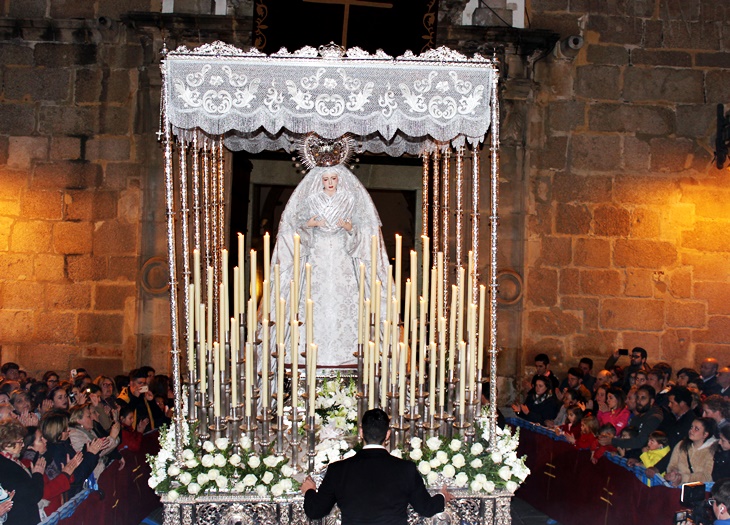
[522,0,730,378]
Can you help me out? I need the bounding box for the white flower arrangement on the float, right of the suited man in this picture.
[395,417,530,494]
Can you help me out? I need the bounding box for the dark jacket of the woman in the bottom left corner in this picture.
[0,456,43,525]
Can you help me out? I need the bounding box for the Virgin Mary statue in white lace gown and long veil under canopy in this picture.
[271,164,388,367]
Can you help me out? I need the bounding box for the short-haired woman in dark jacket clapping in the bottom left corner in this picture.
[0,419,46,525]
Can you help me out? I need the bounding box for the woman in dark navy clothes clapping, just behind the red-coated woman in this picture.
[41,411,104,497]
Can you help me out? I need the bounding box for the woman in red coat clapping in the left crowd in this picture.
[21,428,83,516]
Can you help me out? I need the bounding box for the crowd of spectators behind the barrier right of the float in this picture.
[512,347,730,486]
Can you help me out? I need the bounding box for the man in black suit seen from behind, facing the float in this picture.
[301,408,453,525]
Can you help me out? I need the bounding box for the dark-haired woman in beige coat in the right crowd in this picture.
[664,417,717,487]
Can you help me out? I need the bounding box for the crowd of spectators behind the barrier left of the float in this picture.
[0,362,173,525]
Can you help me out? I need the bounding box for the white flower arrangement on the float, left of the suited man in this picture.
[147,424,299,500]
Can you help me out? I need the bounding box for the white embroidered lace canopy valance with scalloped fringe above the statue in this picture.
[163,42,498,155]
